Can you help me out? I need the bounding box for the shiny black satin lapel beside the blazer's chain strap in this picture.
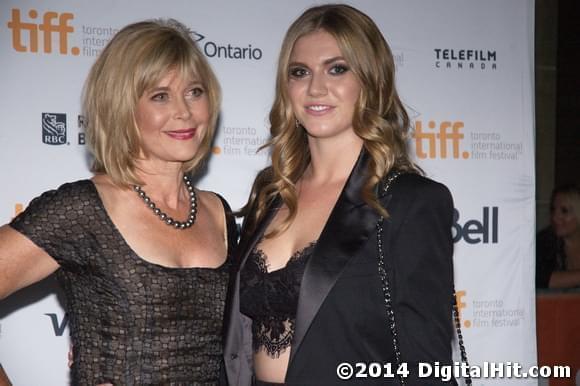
[289,151,378,366]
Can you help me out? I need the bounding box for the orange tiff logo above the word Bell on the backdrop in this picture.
[413,121,470,159]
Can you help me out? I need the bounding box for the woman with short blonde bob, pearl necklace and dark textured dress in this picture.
[0,20,237,385]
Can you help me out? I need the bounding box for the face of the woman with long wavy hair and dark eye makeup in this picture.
[288,30,361,144]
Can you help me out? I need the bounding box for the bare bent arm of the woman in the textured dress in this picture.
[0,225,59,299]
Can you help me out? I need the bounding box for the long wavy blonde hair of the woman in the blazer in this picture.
[242,4,420,237]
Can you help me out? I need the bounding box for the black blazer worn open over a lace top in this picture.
[224,151,454,386]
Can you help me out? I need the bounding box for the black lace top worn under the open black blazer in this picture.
[240,241,316,358]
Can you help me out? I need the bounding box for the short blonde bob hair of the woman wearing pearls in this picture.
[83,19,220,186]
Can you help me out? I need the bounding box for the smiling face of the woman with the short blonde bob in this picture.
[135,71,210,169]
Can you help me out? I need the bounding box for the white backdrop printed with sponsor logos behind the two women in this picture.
[0,0,536,385]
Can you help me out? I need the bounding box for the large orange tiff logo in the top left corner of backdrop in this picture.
[8,8,80,55]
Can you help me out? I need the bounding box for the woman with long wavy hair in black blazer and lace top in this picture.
[225,4,454,386]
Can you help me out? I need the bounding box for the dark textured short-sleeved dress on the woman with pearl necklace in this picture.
[10,180,236,386]
